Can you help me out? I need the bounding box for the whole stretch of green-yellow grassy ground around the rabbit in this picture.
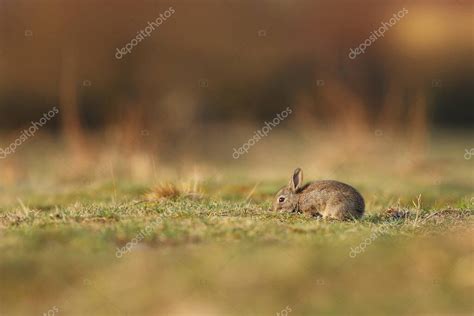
[0,134,474,315]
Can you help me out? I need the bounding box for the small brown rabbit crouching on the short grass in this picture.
[273,168,365,220]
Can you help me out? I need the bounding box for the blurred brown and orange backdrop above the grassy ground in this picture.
[0,0,474,193]
